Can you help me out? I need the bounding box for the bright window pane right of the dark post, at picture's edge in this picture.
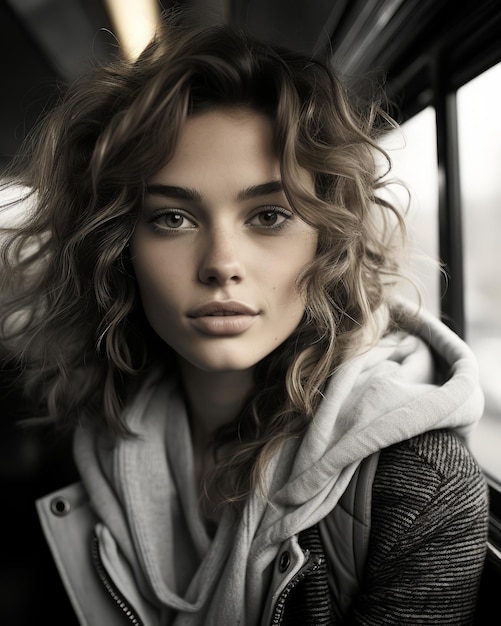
[457,64,501,480]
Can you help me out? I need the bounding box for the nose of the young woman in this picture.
[198,229,245,285]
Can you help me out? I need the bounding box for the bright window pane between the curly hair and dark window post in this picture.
[381,107,440,314]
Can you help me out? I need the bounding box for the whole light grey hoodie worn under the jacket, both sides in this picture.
[75,302,483,626]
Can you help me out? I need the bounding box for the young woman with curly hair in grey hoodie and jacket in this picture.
[2,9,487,625]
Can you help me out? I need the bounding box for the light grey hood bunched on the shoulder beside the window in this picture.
[258,294,484,537]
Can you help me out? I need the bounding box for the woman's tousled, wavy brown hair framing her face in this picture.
[0,8,405,503]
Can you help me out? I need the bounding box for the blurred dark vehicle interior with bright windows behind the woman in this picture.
[0,0,501,626]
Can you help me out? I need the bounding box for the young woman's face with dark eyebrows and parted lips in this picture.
[131,110,317,372]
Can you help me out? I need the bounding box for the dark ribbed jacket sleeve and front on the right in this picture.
[272,431,488,626]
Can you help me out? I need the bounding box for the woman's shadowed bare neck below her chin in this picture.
[180,360,253,443]
